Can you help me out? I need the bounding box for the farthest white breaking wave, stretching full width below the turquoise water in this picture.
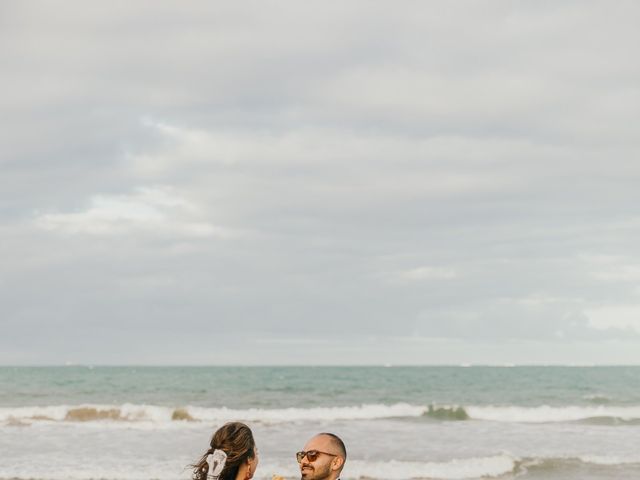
[0,403,640,425]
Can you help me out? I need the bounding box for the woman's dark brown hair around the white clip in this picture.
[191,422,256,480]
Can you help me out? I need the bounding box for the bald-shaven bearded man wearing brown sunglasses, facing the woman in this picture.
[296,433,347,480]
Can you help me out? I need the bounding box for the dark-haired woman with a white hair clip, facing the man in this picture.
[191,422,258,480]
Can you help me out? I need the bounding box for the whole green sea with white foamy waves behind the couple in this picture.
[0,366,640,480]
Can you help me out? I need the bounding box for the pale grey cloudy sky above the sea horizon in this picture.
[0,0,640,365]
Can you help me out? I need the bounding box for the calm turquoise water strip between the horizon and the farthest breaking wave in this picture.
[0,367,640,408]
